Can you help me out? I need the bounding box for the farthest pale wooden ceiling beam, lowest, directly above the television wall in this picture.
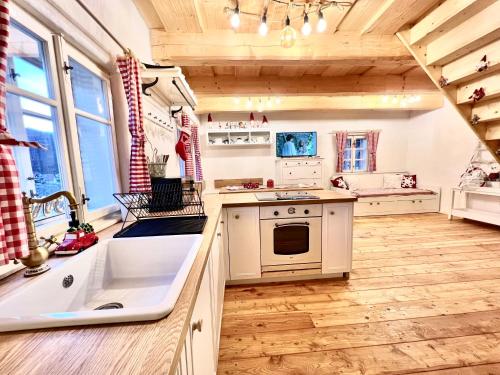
[196,92,443,114]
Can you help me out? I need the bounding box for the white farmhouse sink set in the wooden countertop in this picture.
[0,234,202,332]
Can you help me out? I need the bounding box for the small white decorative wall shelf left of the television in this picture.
[207,128,273,147]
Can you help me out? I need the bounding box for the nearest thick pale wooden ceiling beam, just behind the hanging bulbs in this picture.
[151,30,414,66]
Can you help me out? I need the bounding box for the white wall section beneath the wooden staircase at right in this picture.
[407,99,493,212]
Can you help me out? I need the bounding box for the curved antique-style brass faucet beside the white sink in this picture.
[21,191,78,277]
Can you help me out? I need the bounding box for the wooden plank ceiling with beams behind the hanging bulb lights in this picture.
[135,0,440,111]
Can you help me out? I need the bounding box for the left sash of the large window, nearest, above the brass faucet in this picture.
[6,20,71,223]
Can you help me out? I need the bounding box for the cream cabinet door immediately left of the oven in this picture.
[227,207,261,280]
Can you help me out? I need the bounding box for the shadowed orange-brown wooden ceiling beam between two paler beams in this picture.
[188,74,436,97]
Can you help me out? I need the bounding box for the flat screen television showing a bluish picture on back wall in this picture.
[276,132,318,158]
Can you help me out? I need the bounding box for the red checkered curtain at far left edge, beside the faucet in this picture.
[0,0,29,265]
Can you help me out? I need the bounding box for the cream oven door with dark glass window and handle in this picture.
[260,217,321,266]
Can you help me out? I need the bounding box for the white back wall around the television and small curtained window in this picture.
[200,111,409,188]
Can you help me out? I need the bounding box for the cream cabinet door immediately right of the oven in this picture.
[321,203,353,273]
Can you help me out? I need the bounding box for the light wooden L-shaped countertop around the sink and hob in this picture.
[0,190,356,375]
